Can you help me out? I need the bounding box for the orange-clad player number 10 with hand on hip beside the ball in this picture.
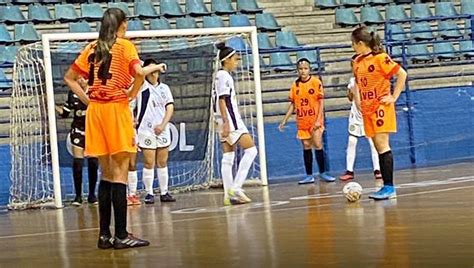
[351,26,407,200]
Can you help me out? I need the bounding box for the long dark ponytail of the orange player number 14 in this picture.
[95,8,127,62]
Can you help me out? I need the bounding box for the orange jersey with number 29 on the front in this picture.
[289,76,324,130]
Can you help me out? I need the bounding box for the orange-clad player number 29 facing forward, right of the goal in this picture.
[278,58,336,184]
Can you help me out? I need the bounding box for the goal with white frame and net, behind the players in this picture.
[9,27,267,209]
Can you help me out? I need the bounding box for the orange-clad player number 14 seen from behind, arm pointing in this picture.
[64,8,166,249]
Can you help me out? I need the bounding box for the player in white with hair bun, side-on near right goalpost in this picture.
[212,43,257,205]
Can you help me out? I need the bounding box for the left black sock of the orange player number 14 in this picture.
[99,180,112,236]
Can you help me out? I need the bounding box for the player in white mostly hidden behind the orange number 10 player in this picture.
[339,77,382,184]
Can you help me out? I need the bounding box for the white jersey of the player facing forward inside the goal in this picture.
[135,80,174,136]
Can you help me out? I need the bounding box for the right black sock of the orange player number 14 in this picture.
[112,183,128,239]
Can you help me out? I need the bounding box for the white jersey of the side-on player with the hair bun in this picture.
[213,70,246,131]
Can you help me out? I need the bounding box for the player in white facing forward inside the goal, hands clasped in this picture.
[129,59,176,204]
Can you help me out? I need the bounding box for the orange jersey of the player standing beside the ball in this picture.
[353,53,400,115]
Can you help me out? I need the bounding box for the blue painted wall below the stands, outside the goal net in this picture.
[0,87,474,205]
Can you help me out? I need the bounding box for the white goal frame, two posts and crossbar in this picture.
[12,26,268,208]
